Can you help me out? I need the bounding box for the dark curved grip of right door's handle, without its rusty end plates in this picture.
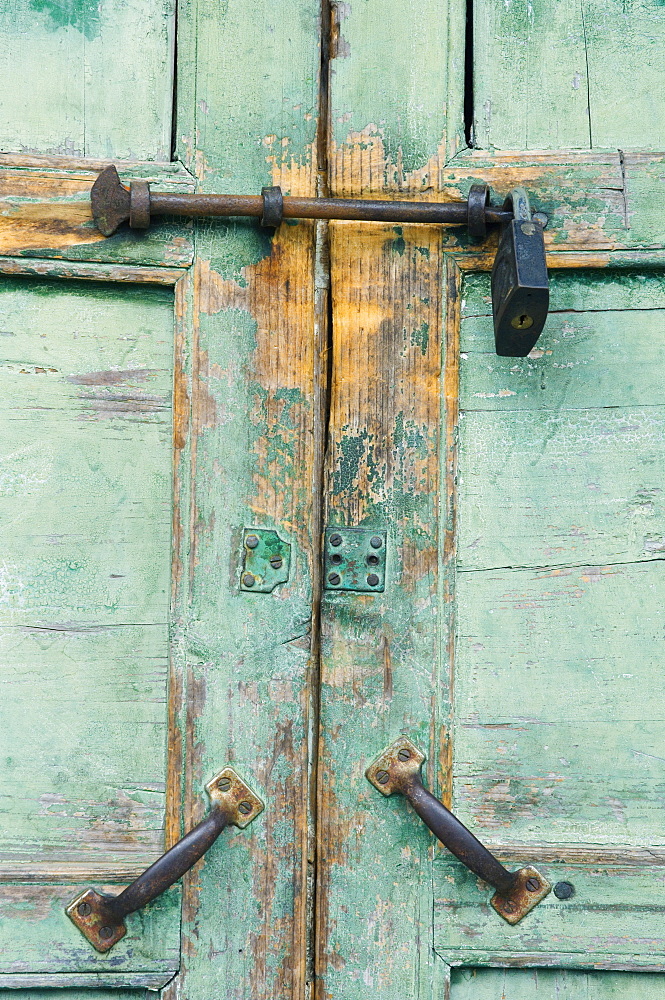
[400,774,518,894]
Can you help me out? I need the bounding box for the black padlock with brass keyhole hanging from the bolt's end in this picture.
[492,188,550,358]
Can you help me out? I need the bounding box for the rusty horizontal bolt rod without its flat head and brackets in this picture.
[150,192,513,226]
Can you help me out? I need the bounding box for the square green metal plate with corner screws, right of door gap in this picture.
[323,528,387,594]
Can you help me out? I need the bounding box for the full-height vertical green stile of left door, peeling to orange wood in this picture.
[173,0,320,1000]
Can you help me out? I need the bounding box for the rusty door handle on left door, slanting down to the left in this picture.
[65,767,263,952]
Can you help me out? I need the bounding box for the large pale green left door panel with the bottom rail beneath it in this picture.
[0,277,179,982]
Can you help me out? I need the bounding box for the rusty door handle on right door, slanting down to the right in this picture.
[365,736,552,924]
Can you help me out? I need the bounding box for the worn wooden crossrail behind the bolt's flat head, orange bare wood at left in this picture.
[0,155,194,267]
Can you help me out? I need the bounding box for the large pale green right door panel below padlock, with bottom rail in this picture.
[435,271,665,968]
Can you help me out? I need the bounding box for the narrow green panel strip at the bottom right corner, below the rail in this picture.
[450,969,663,1000]
